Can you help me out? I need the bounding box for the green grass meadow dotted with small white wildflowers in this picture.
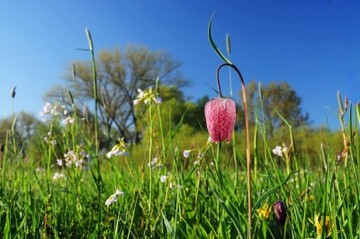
[0,27,360,238]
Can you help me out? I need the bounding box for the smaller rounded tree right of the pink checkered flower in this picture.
[247,81,309,135]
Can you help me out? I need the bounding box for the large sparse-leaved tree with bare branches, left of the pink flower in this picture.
[45,46,187,145]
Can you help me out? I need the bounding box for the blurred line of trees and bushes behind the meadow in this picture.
[0,46,343,166]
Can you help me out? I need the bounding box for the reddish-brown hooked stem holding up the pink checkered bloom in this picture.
[216,63,252,239]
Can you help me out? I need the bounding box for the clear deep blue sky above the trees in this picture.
[0,0,360,128]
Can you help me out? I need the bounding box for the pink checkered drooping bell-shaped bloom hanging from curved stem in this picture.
[205,97,236,142]
